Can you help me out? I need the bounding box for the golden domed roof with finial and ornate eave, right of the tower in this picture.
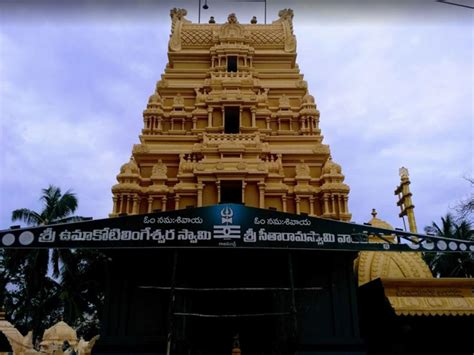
[354,209,474,316]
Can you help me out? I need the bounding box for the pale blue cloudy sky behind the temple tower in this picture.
[0,0,474,229]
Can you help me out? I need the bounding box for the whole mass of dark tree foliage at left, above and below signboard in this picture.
[0,185,106,338]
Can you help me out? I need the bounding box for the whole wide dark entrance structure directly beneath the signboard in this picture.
[96,249,360,355]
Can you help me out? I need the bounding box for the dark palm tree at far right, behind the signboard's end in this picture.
[423,213,474,277]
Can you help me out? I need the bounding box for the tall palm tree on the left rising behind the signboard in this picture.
[5,185,84,335]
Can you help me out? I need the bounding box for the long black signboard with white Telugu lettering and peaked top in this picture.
[0,204,474,252]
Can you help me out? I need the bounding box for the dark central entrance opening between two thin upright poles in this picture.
[174,252,294,355]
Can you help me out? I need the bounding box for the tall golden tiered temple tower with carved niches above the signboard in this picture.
[111,9,351,221]
